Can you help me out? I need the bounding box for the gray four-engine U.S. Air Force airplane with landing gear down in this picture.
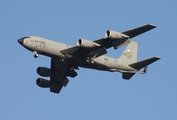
[18,24,160,93]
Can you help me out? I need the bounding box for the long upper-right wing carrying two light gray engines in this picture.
[60,24,155,60]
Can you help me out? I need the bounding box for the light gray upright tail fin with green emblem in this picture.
[118,41,138,64]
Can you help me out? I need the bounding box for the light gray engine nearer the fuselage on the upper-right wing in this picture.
[77,39,100,48]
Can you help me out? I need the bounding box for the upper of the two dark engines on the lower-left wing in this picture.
[37,67,53,77]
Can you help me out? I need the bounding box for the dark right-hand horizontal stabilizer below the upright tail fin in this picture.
[129,57,160,70]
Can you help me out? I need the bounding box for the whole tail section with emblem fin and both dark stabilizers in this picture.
[118,41,160,80]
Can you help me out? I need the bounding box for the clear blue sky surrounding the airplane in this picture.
[0,0,177,120]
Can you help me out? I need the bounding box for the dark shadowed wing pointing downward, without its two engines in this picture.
[50,58,77,93]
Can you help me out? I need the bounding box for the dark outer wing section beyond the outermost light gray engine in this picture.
[122,24,156,38]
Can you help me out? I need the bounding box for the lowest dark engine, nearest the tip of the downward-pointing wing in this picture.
[36,78,51,88]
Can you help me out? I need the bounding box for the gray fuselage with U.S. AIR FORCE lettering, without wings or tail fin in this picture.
[20,36,135,72]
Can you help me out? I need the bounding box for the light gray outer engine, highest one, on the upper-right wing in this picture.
[105,30,128,39]
